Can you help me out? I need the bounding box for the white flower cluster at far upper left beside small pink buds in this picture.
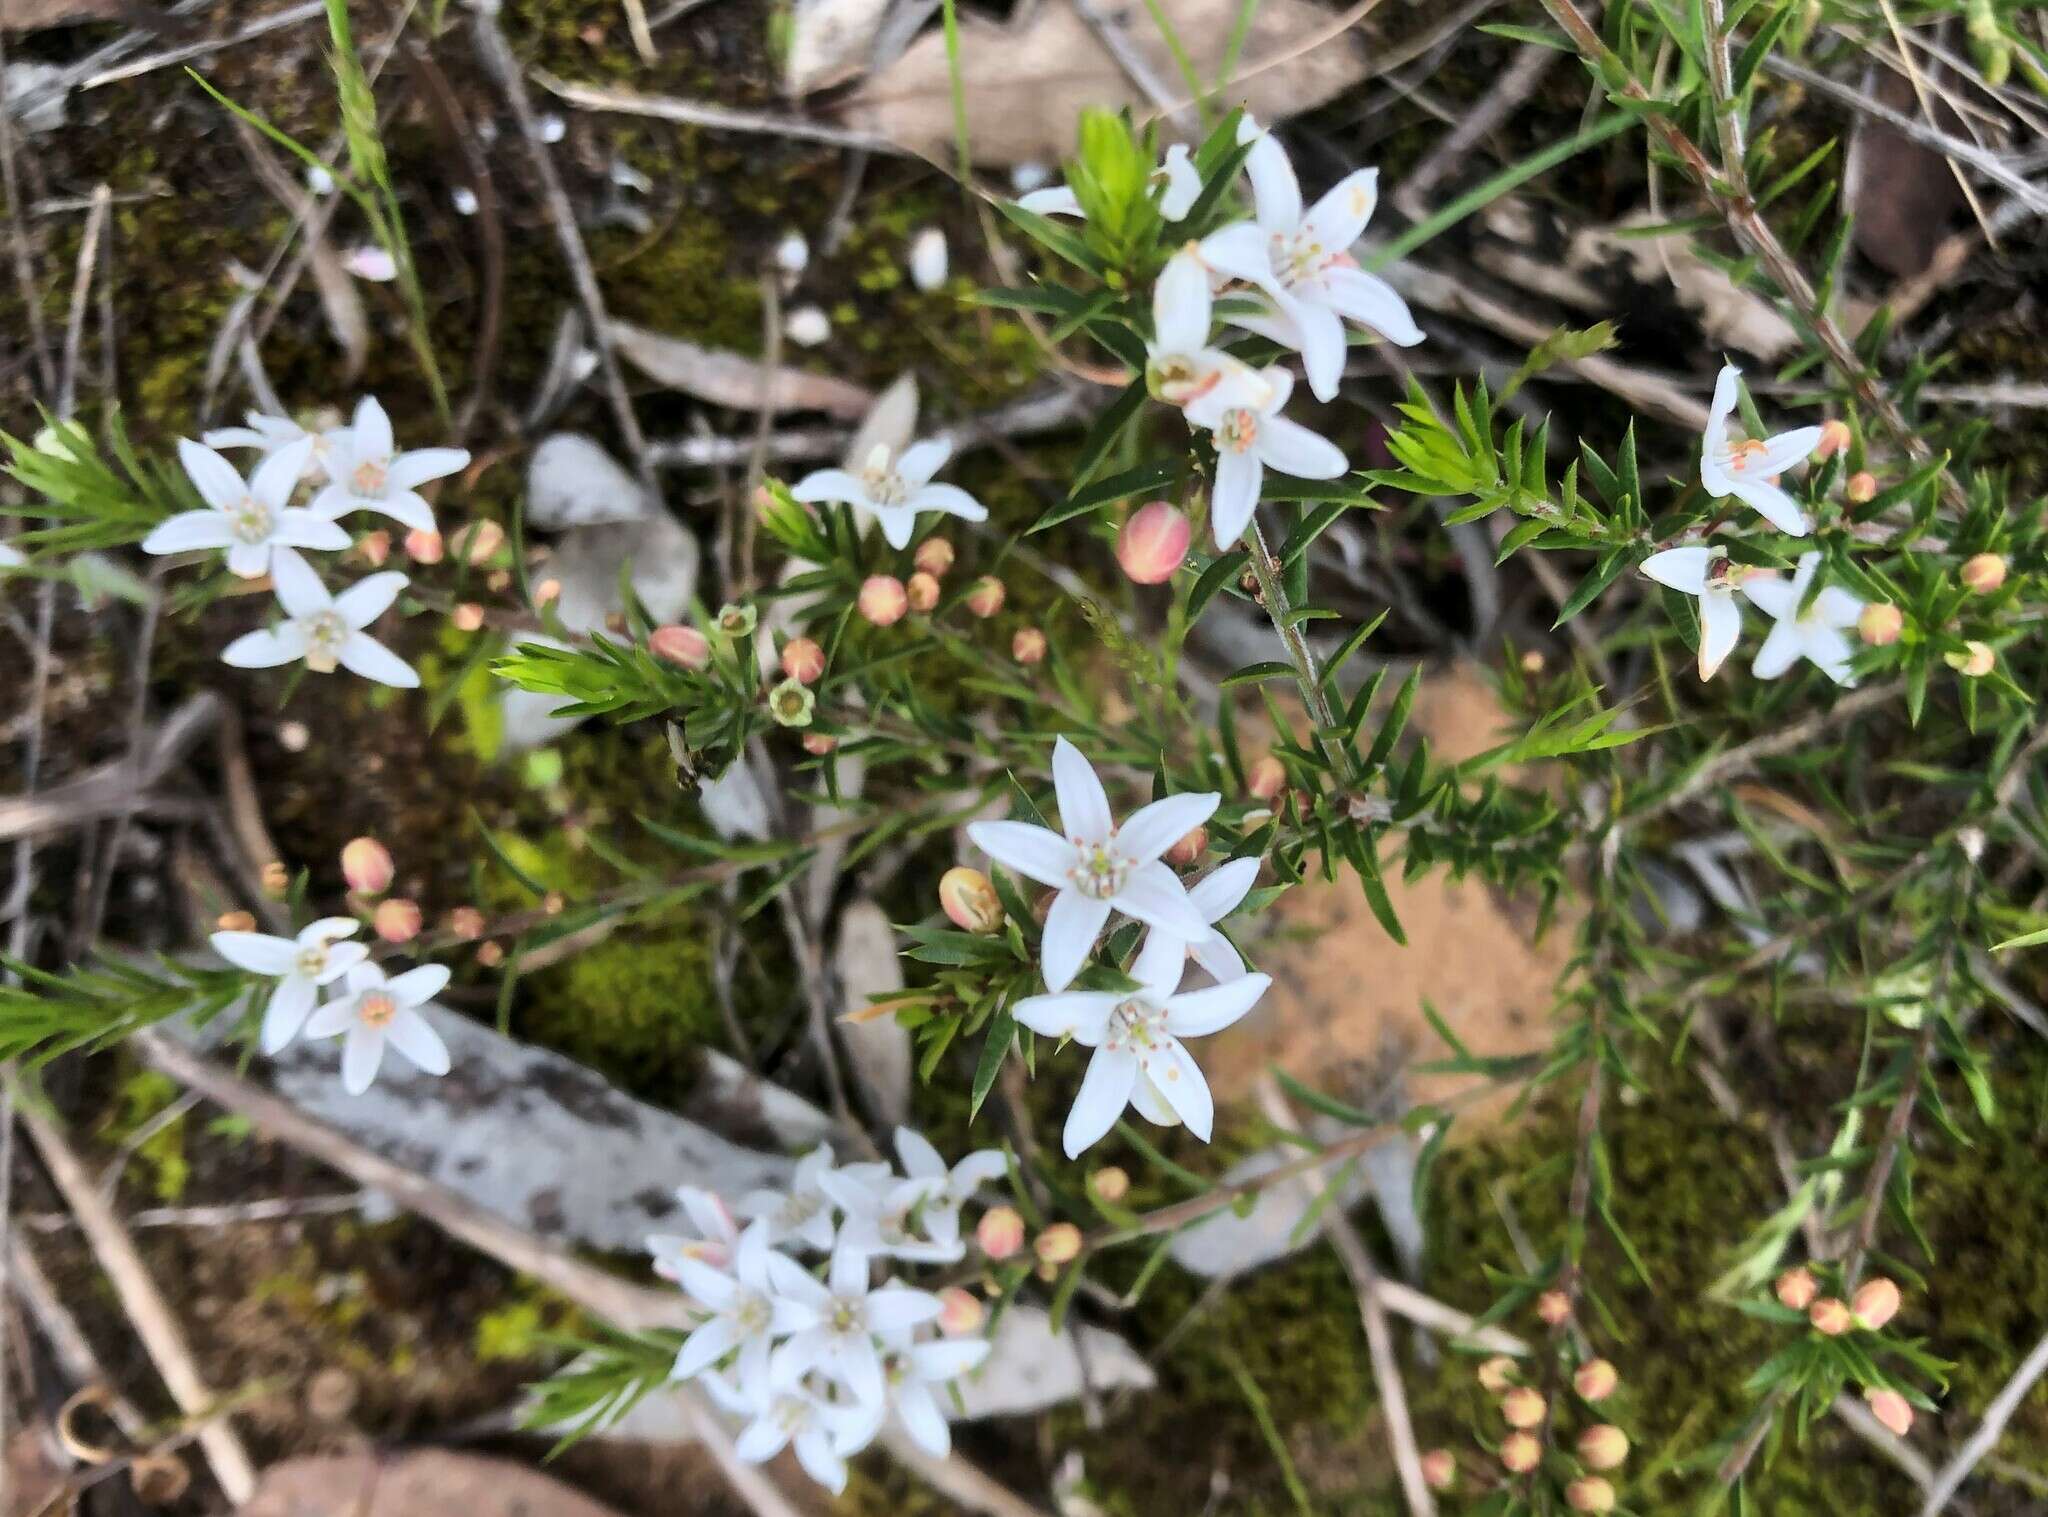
[141,397,469,690]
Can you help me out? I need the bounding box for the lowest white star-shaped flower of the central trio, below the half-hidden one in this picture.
[1012,934,1272,1159]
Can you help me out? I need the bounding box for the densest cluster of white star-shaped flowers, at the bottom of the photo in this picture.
[647,1128,1008,1490]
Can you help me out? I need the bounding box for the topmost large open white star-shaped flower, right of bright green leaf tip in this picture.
[1202,117,1423,401]
